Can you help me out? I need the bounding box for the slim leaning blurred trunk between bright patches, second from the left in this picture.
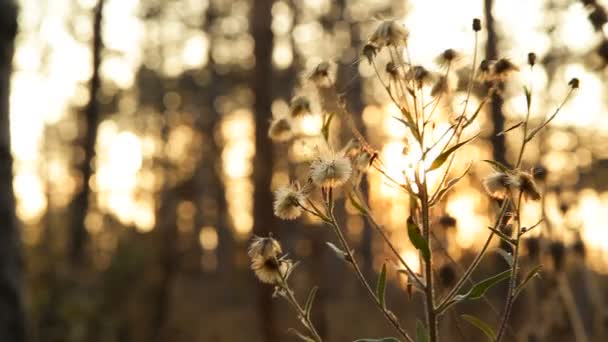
[69,0,105,266]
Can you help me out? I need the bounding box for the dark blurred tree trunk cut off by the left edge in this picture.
[0,0,25,342]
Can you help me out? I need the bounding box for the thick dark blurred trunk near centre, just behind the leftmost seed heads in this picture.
[250,0,281,342]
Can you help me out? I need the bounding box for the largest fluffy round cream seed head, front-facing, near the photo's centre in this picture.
[310,151,352,187]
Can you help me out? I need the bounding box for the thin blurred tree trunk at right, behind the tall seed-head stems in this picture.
[484,0,508,165]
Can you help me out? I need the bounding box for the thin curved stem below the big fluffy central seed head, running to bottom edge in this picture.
[327,195,414,342]
